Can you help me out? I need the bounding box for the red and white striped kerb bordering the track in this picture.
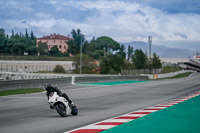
[65,91,200,133]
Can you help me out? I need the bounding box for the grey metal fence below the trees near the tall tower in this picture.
[122,69,162,75]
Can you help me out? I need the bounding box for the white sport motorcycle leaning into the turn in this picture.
[48,92,78,117]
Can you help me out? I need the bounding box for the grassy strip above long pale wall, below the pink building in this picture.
[0,55,73,61]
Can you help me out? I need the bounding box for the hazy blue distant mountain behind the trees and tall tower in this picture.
[122,41,194,58]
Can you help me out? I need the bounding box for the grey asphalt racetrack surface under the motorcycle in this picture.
[0,73,200,133]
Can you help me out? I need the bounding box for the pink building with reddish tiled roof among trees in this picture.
[36,33,71,53]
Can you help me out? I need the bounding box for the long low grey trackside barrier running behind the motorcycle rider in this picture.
[0,76,148,90]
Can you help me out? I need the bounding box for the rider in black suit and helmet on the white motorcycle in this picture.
[44,83,73,109]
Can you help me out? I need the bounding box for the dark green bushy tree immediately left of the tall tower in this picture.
[132,49,147,69]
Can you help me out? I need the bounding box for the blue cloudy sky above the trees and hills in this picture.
[0,0,200,51]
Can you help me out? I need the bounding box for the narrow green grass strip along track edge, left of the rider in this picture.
[0,88,44,96]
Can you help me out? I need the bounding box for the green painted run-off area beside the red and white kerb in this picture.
[101,96,200,133]
